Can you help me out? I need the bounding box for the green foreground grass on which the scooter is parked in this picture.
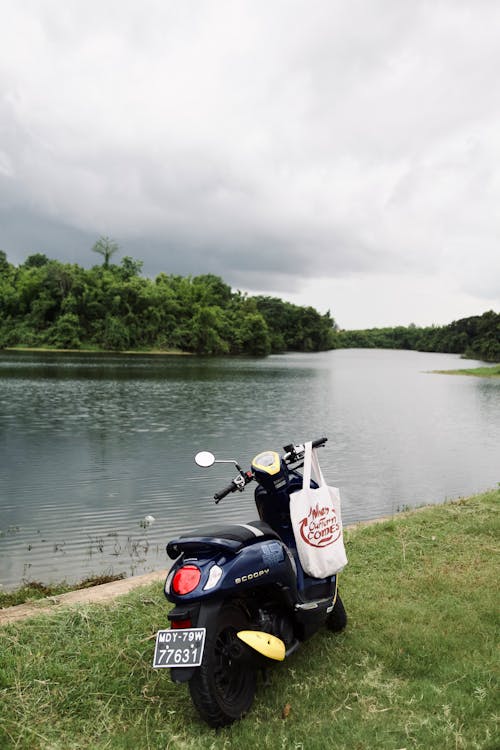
[0,490,500,750]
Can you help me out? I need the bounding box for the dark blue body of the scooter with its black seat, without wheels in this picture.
[165,450,337,682]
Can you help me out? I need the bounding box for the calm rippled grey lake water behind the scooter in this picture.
[0,349,500,589]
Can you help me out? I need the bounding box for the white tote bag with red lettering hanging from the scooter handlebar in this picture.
[290,442,347,578]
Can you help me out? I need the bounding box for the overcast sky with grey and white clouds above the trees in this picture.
[0,0,500,328]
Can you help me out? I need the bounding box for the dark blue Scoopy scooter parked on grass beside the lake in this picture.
[153,437,347,727]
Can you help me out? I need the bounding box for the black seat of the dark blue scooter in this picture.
[167,520,281,559]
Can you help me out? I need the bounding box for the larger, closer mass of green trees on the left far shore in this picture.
[0,250,336,355]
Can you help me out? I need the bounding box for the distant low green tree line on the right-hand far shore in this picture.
[336,310,500,362]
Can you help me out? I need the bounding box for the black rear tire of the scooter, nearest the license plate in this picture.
[189,604,257,727]
